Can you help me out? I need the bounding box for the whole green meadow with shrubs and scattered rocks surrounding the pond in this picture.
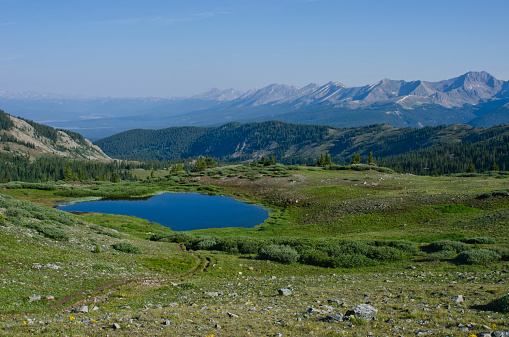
[0,164,509,336]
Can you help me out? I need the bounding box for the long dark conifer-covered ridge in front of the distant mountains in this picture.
[95,121,509,175]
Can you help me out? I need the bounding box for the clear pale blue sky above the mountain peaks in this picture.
[0,0,509,97]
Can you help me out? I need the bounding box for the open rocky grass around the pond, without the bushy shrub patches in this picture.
[0,169,509,336]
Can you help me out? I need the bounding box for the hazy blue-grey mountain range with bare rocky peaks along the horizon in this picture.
[0,71,509,140]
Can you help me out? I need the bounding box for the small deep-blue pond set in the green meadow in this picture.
[57,193,269,231]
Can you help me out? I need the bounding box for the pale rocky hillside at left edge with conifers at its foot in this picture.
[0,110,129,183]
